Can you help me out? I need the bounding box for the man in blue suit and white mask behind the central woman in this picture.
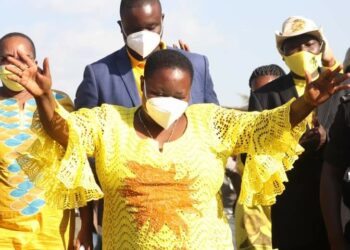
[75,0,218,109]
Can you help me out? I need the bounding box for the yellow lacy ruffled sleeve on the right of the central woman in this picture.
[214,99,306,206]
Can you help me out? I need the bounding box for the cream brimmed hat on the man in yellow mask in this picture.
[275,16,325,55]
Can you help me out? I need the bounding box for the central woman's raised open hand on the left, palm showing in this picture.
[6,50,52,98]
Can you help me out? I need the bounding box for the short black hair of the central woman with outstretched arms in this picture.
[145,49,193,82]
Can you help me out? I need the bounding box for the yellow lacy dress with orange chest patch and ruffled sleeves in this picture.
[18,100,305,250]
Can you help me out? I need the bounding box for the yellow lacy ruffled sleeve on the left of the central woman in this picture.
[17,104,103,209]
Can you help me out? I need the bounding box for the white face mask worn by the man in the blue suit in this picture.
[122,23,163,58]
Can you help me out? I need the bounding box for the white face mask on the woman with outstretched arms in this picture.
[144,84,188,129]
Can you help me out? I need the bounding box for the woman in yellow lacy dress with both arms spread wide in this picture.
[7,50,349,249]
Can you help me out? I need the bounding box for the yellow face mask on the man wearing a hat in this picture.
[283,51,322,77]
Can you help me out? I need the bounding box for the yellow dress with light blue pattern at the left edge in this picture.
[0,92,72,250]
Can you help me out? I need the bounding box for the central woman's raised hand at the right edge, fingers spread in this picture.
[304,66,350,107]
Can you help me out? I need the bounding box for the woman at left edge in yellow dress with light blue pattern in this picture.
[0,33,74,250]
